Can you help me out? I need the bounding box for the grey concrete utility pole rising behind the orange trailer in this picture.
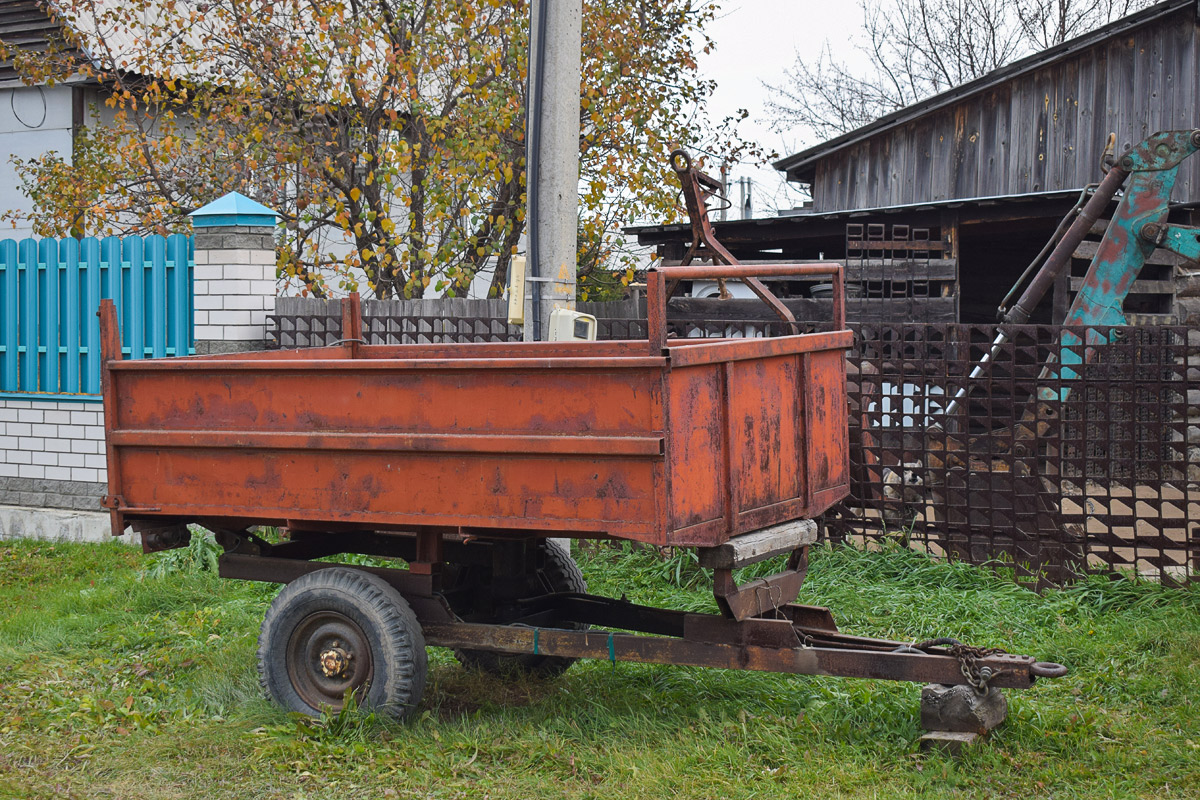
[524,0,583,341]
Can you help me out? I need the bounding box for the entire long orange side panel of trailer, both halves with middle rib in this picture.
[109,345,665,540]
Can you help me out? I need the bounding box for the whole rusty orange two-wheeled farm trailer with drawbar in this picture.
[101,264,1055,716]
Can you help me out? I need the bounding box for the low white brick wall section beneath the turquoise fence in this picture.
[0,398,108,482]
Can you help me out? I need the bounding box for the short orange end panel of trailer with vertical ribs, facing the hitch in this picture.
[667,332,851,546]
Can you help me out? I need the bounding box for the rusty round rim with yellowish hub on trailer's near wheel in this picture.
[287,610,374,710]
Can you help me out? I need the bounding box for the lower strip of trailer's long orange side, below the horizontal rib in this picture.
[118,445,661,541]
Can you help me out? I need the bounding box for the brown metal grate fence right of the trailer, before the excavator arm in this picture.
[826,324,1200,583]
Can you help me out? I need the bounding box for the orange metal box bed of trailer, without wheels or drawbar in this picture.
[103,321,852,547]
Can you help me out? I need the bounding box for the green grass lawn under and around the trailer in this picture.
[0,542,1200,800]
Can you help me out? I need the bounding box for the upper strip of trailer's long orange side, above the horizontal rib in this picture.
[114,362,661,435]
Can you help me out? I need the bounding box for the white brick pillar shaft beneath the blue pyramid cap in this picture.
[194,248,275,342]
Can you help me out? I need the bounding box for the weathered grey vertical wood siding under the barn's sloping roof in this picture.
[812,6,1200,211]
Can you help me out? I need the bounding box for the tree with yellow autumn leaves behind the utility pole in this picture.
[0,0,736,297]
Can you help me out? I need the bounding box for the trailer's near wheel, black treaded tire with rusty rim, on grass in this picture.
[258,567,427,720]
